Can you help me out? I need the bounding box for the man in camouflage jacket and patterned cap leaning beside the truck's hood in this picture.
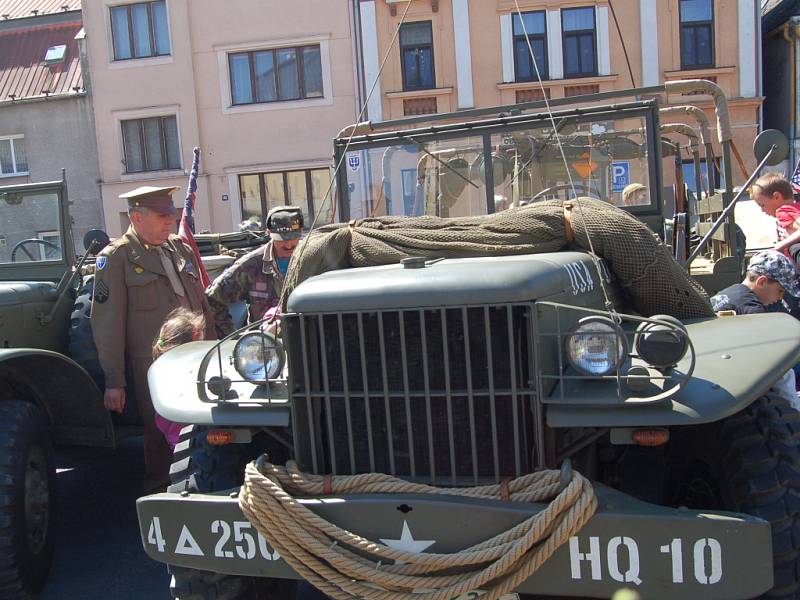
[206,206,303,337]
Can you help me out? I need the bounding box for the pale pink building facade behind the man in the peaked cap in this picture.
[79,0,357,237]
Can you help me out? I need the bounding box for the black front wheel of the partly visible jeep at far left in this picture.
[0,400,55,600]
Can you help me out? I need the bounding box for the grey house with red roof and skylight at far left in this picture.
[0,0,103,262]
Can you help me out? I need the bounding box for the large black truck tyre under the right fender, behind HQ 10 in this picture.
[674,394,800,600]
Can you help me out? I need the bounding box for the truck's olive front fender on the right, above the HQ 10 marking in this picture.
[546,313,800,427]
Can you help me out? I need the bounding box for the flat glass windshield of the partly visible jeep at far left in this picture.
[0,191,64,264]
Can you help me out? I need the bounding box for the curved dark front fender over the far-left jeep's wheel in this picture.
[0,348,115,448]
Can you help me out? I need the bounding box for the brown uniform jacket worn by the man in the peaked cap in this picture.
[92,226,216,387]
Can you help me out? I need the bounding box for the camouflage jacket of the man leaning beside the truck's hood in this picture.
[206,242,283,337]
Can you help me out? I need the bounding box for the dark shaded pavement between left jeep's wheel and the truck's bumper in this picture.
[41,437,170,600]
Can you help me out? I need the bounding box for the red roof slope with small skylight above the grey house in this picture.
[0,22,83,102]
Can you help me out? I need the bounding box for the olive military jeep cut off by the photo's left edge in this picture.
[0,180,115,598]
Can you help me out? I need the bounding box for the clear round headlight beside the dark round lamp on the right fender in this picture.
[567,316,627,376]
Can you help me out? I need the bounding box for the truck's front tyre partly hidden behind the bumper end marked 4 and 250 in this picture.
[167,425,296,600]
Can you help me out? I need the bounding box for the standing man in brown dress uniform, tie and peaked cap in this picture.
[92,186,215,491]
